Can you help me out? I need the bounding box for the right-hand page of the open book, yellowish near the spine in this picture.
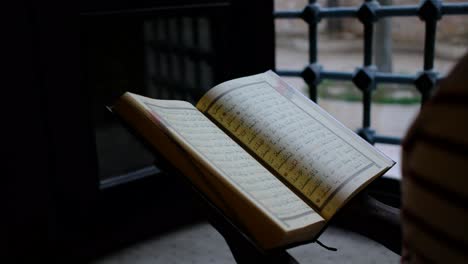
[197,71,394,219]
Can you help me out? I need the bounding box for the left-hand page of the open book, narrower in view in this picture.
[128,95,323,231]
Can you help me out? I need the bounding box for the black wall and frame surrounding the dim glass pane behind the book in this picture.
[0,1,274,263]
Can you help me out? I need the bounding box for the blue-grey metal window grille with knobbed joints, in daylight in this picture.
[274,0,468,144]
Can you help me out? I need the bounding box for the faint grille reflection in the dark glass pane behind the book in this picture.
[144,16,214,102]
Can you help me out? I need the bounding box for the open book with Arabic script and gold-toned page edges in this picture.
[113,71,394,249]
